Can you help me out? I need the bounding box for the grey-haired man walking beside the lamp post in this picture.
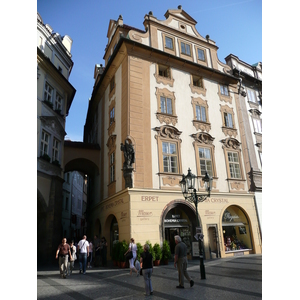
[174,235,194,289]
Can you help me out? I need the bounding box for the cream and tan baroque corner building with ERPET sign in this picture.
[84,6,262,258]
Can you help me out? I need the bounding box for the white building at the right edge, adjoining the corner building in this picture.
[225,54,262,235]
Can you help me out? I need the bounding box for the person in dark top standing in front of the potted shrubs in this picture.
[140,244,153,296]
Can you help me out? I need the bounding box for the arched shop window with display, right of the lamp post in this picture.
[222,205,252,253]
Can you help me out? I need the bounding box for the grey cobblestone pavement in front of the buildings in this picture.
[37,255,262,300]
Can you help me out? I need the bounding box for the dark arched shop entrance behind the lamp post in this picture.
[162,200,197,257]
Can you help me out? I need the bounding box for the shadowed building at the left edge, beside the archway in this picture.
[37,13,76,263]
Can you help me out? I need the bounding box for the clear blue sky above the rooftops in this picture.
[37,0,262,141]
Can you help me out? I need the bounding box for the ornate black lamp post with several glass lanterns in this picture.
[179,168,212,279]
